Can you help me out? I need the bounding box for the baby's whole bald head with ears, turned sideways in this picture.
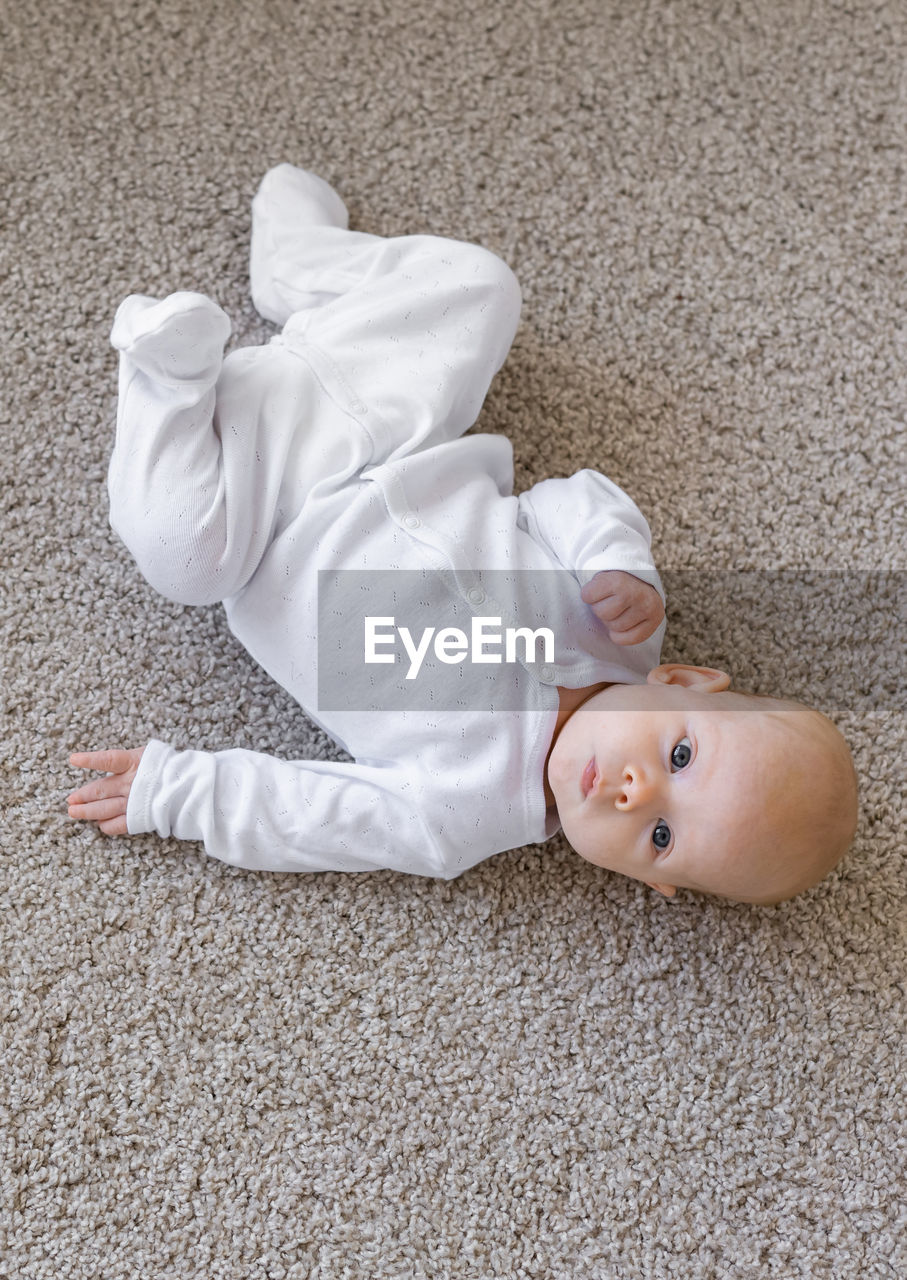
[548,663,857,905]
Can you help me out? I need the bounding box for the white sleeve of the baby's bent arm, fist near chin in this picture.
[519,470,664,599]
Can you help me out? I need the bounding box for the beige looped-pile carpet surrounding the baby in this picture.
[0,0,907,1280]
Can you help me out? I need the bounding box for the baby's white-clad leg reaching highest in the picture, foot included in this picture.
[252,165,521,461]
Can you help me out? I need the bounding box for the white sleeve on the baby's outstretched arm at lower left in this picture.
[127,740,453,879]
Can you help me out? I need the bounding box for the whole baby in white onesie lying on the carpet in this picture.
[69,165,857,904]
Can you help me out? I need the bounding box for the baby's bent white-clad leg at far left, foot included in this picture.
[107,293,290,604]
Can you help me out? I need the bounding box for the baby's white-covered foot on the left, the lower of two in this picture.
[110,292,230,385]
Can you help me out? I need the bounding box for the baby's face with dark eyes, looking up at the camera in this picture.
[548,684,828,897]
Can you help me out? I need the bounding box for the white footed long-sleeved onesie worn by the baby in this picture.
[109,165,664,878]
